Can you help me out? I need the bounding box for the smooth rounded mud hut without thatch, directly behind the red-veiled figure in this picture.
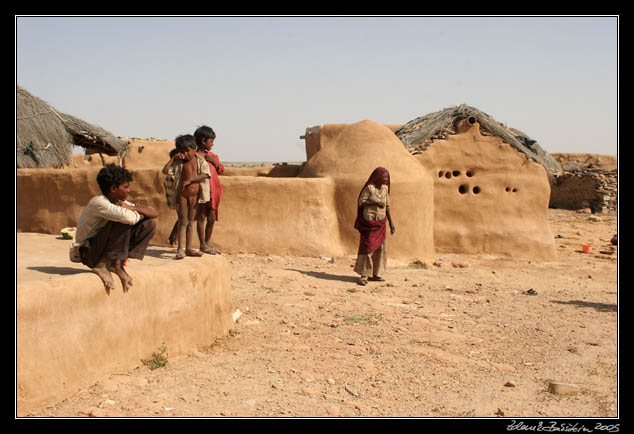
[299,120,435,260]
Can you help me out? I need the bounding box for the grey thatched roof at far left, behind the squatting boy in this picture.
[16,86,129,168]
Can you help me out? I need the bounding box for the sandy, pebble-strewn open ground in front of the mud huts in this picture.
[22,210,619,418]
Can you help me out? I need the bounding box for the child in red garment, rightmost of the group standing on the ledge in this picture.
[194,125,225,255]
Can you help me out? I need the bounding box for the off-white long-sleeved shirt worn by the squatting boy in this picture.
[75,195,142,244]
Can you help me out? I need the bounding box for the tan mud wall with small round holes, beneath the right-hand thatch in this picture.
[415,123,555,260]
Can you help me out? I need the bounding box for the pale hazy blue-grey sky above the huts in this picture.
[15,16,619,162]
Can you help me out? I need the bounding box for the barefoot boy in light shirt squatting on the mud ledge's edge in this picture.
[75,164,158,295]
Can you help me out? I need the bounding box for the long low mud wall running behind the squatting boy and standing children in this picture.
[16,166,424,258]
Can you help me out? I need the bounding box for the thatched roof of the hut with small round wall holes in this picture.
[396,104,561,176]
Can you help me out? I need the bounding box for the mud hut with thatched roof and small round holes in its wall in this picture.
[395,104,561,259]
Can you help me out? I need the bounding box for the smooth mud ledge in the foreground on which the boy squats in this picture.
[16,233,232,416]
